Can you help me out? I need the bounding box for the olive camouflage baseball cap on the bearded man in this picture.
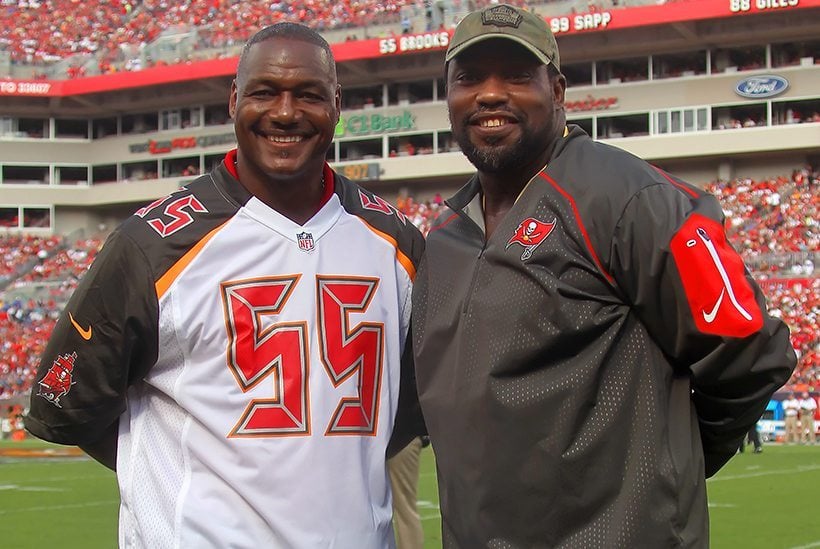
[444,4,561,70]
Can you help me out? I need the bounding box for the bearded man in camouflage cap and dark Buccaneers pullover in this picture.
[413,4,796,549]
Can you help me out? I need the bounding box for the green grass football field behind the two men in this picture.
[0,441,820,549]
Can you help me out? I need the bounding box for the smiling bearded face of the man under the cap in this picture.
[447,39,566,175]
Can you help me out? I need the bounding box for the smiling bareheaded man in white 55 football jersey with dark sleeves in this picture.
[26,23,423,549]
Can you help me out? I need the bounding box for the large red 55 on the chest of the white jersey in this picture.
[221,275,384,436]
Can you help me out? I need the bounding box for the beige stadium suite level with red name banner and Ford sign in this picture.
[0,0,820,233]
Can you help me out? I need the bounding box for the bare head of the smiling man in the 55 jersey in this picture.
[229,37,341,186]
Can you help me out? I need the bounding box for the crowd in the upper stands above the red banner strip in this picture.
[0,0,604,78]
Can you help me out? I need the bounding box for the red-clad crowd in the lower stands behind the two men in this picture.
[0,167,820,399]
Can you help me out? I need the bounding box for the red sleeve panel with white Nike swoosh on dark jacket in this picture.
[671,214,763,337]
